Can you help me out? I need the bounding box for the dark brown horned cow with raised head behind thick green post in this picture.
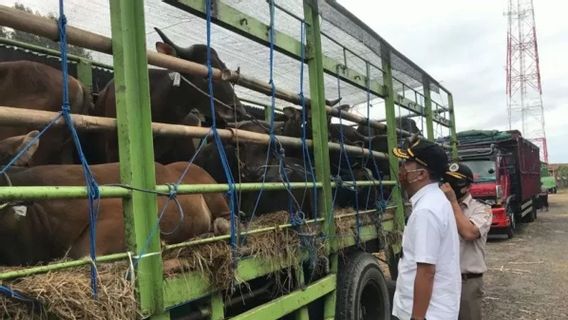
[87,28,250,163]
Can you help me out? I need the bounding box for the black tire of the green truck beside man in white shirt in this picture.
[335,252,391,320]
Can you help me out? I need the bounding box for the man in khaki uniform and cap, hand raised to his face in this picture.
[441,163,492,320]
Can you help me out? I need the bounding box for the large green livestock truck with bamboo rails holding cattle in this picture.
[0,0,455,320]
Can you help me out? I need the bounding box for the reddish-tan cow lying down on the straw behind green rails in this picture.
[0,132,229,265]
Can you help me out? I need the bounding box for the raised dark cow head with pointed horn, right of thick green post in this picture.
[154,28,248,122]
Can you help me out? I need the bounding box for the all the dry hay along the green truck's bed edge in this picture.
[0,209,386,320]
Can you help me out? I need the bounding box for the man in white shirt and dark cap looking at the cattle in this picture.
[393,140,461,320]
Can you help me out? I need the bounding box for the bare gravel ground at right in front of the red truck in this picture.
[483,190,568,320]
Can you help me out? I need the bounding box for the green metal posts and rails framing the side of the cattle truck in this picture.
[0,0,456,320]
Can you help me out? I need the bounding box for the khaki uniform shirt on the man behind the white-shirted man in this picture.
[460,194,493,273]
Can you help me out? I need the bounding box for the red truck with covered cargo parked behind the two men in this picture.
[448,130,540,238]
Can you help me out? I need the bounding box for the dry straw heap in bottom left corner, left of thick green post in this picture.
[0,263,139,320]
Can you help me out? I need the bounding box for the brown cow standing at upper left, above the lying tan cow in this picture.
[0,61,93,165]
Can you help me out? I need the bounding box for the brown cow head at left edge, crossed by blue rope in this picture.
[0,130,39,166]
